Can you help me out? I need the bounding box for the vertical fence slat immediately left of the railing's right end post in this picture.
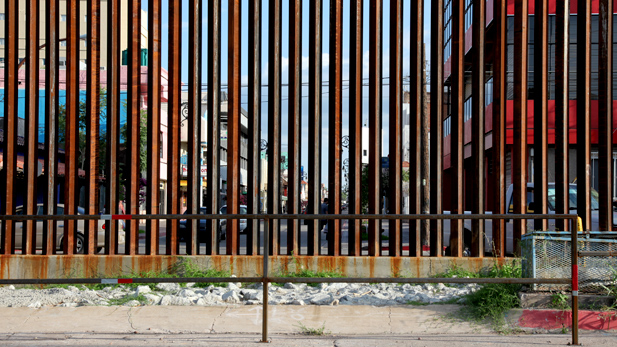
[555,1,570,231]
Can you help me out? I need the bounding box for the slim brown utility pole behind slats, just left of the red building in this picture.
[420,44,434,246]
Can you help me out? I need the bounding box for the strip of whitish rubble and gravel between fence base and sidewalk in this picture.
[0,283,480,308]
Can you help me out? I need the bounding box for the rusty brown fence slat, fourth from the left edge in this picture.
[60,1,80,254]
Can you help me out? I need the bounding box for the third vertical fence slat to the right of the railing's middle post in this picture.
[308,0,323,255]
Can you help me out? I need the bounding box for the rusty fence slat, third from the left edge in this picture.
[44,0,60,255]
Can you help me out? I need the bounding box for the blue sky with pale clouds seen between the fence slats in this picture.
[147,0,431,183]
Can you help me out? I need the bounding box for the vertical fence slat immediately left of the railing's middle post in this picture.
[246,0,262,255]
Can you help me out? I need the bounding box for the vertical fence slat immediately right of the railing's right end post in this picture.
[576,0,592,231]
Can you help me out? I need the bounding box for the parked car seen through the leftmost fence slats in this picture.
[0,204,126,253]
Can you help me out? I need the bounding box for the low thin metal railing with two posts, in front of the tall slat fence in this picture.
[0,214,576,345]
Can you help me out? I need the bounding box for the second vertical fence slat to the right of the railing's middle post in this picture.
[287,0,302,255]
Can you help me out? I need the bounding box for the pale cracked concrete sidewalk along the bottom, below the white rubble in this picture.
[0,305,617,347]
